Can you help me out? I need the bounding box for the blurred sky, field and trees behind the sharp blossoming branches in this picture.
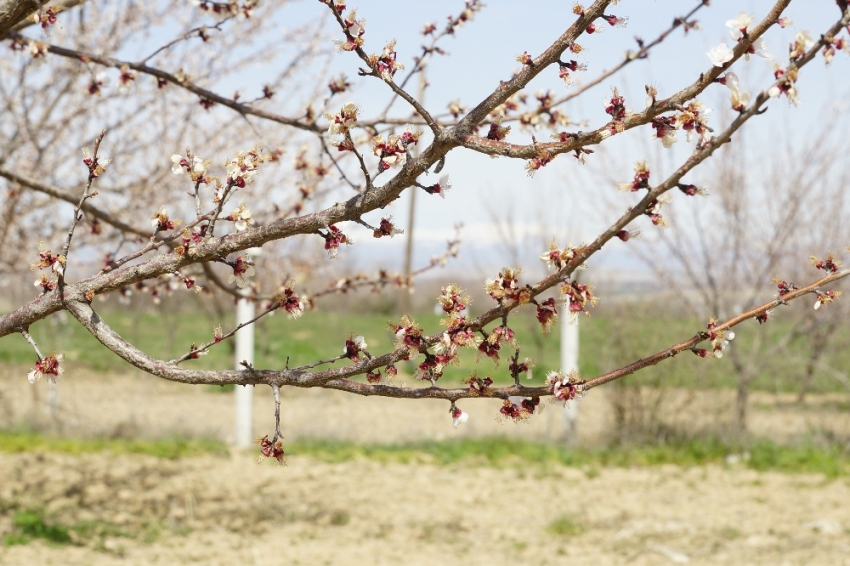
[0,0,850,564]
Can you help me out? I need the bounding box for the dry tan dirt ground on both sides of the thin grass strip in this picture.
[0,368,850,566]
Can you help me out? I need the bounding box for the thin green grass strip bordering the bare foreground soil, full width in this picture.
[0,431,850,479]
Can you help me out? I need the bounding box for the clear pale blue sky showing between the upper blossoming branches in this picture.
[253,0,850,280]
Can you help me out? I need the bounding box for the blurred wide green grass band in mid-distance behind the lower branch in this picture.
[0,305,850,393]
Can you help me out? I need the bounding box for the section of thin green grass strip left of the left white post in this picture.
[0,431,229,460]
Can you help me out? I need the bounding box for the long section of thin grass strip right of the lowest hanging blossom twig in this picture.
[286,438,850,478]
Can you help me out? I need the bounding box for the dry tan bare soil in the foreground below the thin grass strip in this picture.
[0,454,850,565]
